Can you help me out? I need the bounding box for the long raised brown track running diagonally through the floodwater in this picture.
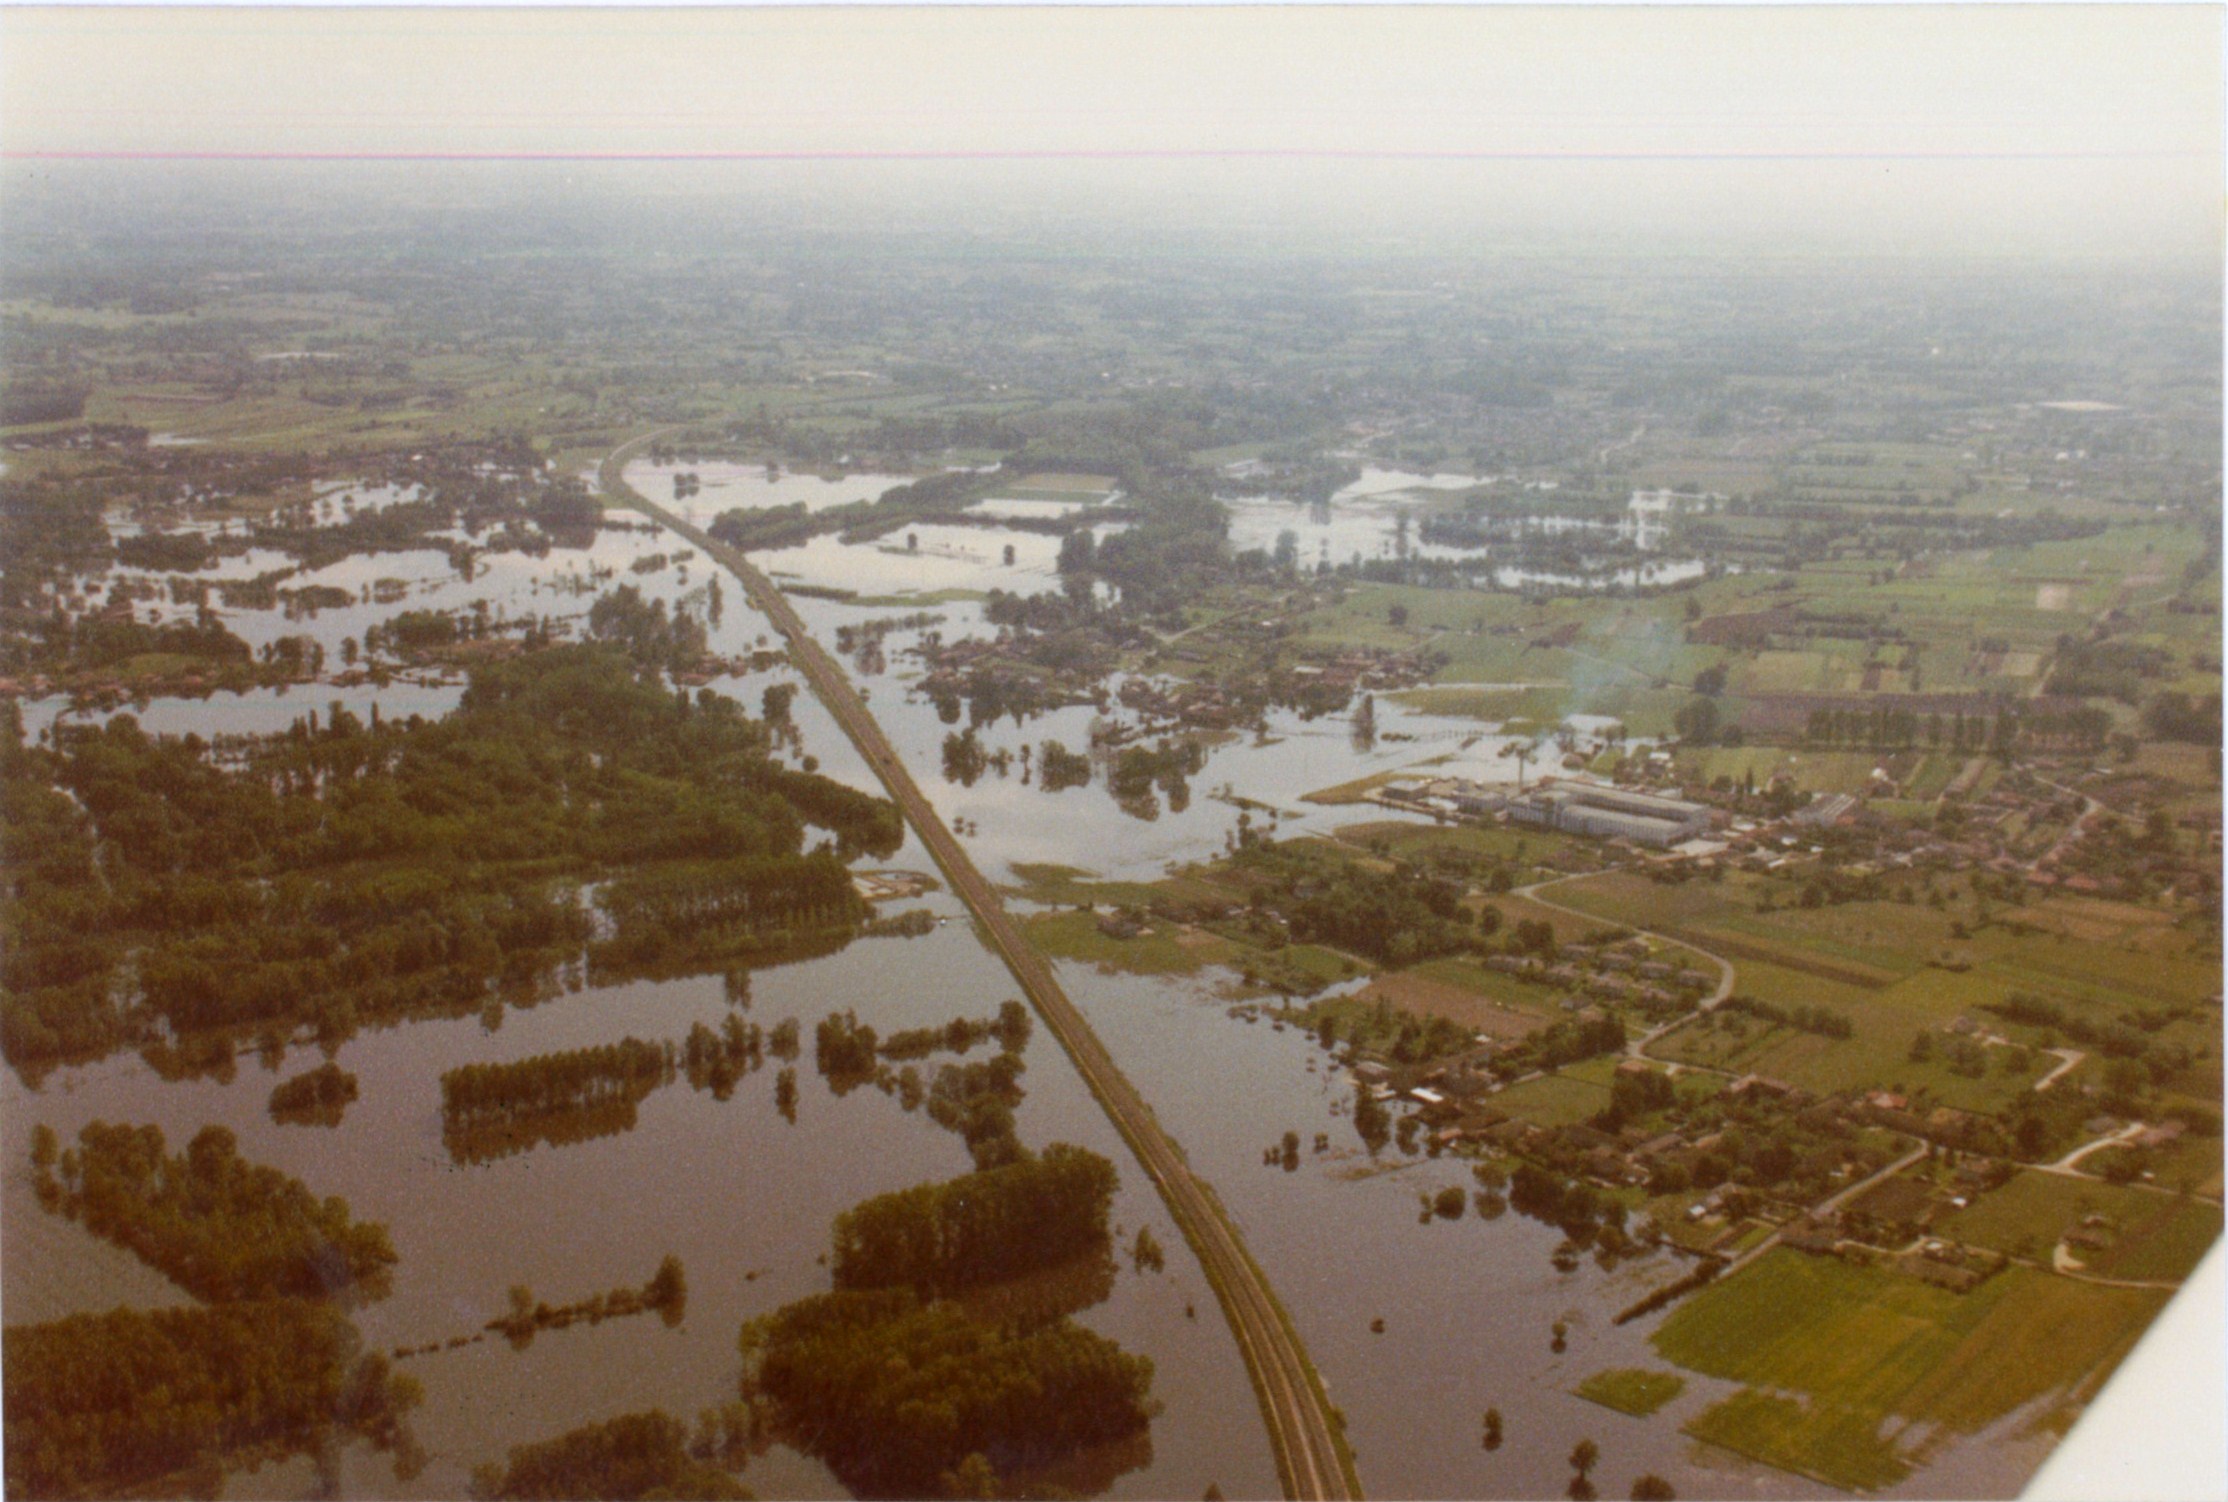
[599,435,1361,1498]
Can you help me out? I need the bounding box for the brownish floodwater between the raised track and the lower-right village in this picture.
[1061,965,1834,1498]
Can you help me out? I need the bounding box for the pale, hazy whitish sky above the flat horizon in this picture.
[0,4,2224,256]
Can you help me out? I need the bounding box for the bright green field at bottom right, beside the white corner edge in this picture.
[1653,1250,2166,1489]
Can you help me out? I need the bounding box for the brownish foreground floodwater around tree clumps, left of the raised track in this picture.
[0,864,1274,1498]
